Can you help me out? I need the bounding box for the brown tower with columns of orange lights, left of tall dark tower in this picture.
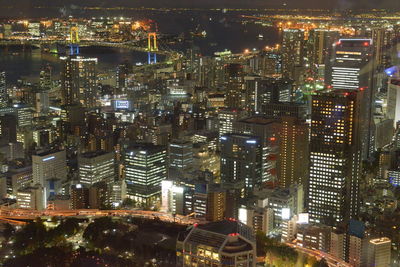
[277,117,309,187]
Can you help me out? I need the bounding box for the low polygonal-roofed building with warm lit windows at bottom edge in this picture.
[176,219,256,267]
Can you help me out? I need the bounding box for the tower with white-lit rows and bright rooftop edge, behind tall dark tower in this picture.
[326,39,375,159]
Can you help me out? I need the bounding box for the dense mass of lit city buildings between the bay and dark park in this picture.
[0,16,400,267]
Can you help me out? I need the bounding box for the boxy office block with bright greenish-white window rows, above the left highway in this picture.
[123,144,167,204]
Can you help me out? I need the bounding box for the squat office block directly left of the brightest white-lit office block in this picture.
[78,151,115,186]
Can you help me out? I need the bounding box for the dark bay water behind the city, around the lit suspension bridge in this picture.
[0,12,279,83]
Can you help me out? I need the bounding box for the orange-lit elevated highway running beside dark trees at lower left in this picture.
[0,207,199,225]
